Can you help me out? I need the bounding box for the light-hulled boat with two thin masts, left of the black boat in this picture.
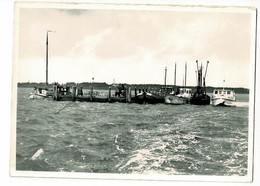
[165,63,192,105]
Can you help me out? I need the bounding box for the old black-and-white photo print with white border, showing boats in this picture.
[10,2,257,182]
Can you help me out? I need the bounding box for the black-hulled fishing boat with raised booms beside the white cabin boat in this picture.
[190,60,210,105]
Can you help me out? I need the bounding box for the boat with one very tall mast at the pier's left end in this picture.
[29,30,53,99]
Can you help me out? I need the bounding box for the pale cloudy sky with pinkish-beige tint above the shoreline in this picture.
[18,5,254,88]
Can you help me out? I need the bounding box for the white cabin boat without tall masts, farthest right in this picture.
[211,88,236,106]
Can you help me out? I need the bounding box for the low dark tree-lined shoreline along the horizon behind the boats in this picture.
[18,82,249,94]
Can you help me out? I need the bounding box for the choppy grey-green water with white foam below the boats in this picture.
[16,88,248,176]
